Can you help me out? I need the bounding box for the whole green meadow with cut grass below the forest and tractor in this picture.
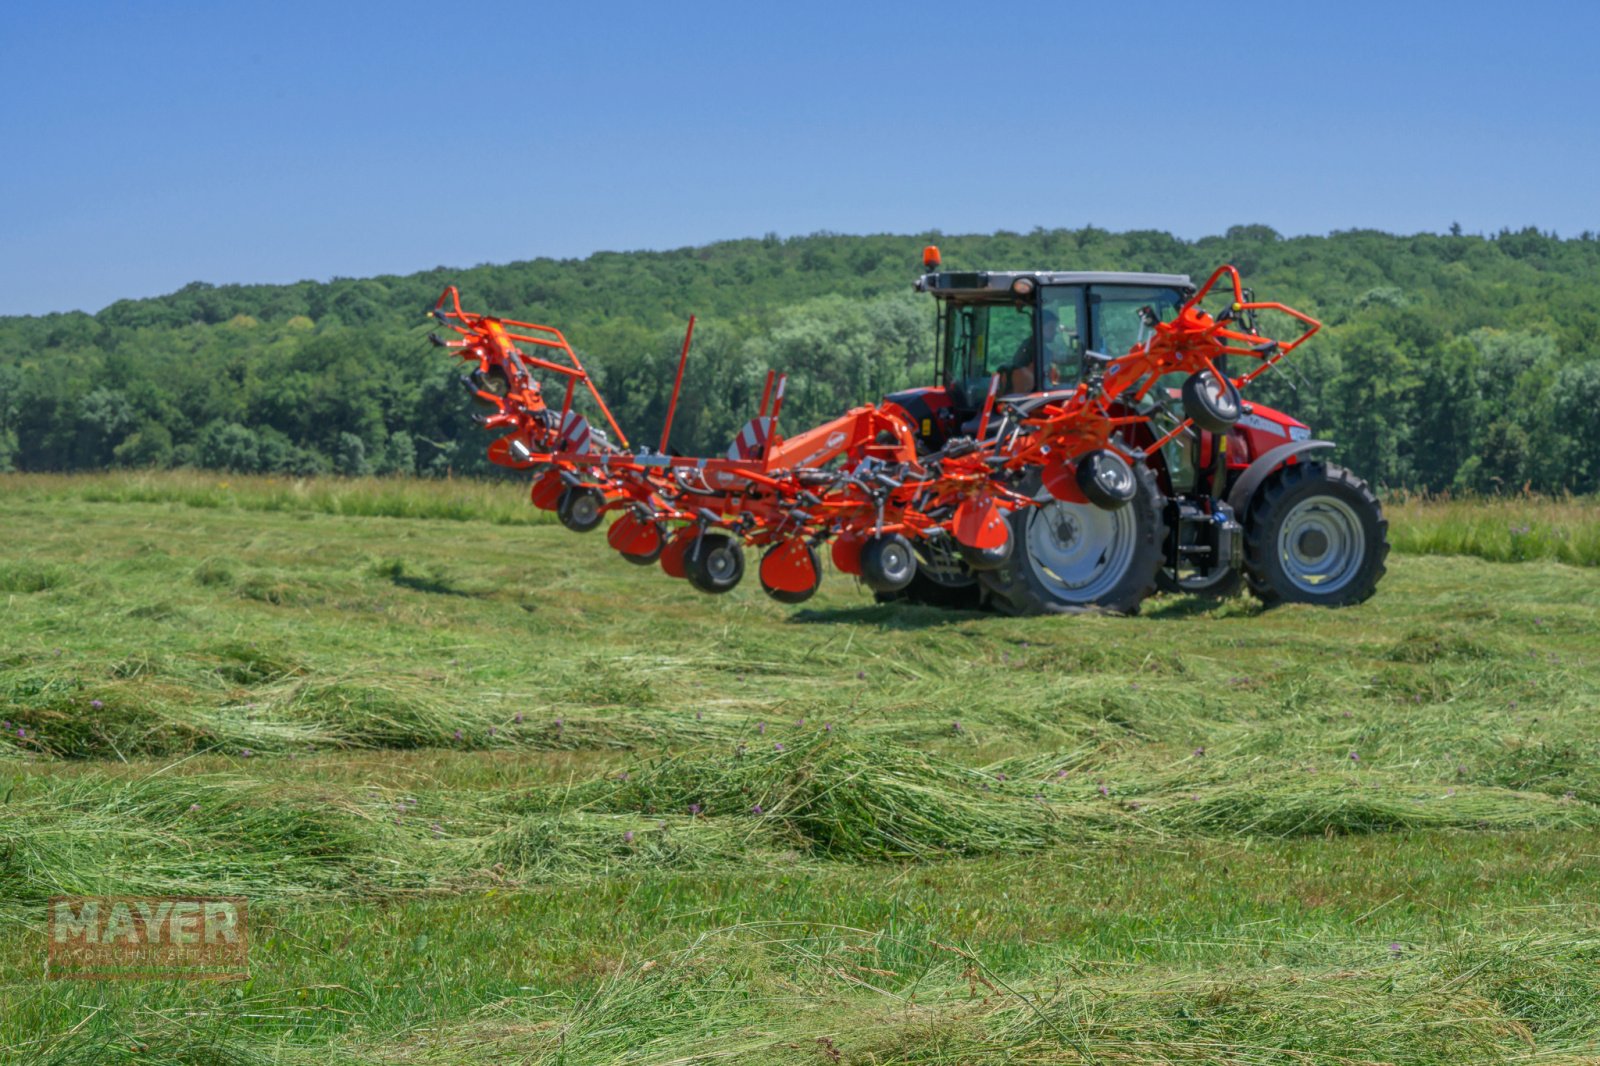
[0,475,1600,1066]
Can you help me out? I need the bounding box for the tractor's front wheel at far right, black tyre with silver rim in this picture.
[1245,461,1389,607]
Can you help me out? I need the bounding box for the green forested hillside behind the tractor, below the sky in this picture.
[0,226,1600,493]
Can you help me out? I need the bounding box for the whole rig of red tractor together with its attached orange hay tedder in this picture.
[432,248,1389,613]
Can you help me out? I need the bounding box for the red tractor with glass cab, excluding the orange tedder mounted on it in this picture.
[878,248,1389,615]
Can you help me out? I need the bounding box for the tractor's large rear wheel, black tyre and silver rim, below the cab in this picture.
[978,463,1166,615]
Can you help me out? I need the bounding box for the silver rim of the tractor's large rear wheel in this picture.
[1026,499,1138,603]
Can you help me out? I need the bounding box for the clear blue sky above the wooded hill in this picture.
[0,0,1600,314]
